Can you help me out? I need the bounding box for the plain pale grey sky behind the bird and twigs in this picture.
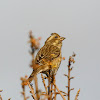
[0,0,100,100]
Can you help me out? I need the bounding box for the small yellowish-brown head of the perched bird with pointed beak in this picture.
[45,33,65,47]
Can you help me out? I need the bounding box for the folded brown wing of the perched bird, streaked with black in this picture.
[35,44,60,64]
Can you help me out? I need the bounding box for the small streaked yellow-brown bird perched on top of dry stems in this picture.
[28,33,65,83]
